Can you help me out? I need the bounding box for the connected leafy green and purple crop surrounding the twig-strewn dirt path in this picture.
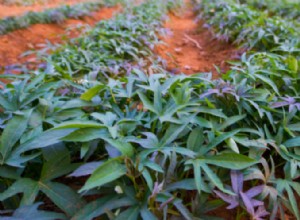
[0,0,300,220]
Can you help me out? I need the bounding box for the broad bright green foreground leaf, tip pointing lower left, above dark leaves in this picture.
[79,158,126,192]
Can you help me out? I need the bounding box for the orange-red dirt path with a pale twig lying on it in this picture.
[156,9,241,77]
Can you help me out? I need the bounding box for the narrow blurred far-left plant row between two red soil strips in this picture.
[0,1,109,35]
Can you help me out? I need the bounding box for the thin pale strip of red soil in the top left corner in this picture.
[0,0,99,18]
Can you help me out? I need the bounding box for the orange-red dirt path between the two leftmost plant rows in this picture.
[0,7,120,67]
